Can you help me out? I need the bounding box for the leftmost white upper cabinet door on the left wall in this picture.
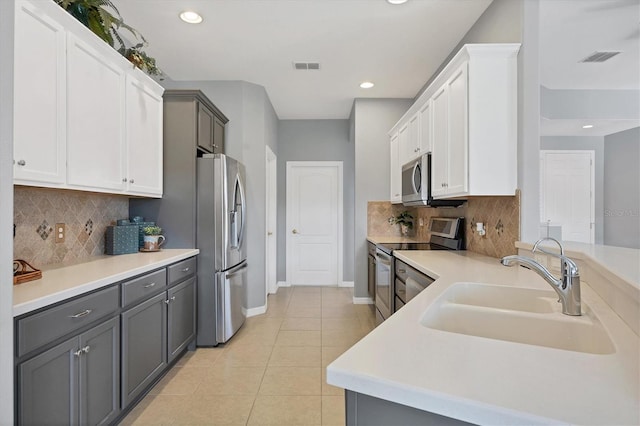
[13,1,66,186]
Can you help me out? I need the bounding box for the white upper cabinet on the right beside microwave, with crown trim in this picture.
[389,44,520,198]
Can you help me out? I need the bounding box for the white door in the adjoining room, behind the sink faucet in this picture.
[540,150,595,244]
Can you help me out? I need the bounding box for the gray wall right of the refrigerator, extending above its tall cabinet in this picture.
[163,81,278,309]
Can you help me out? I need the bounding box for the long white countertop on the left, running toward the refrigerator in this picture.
[13,249,200,317]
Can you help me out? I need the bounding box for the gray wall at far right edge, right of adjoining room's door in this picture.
[604,127,640,249]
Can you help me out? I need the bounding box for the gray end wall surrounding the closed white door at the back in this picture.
[278,120,354,281]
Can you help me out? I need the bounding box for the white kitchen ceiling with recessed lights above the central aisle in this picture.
[113,0,491,119]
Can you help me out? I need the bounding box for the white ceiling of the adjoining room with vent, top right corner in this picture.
[540,0,640,136]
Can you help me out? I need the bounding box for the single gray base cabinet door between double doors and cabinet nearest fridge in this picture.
[122,293,167,407]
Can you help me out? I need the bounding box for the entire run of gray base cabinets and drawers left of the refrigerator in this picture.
[14,257,197,426]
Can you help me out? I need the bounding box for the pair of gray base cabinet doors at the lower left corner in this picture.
[18,318,120,425]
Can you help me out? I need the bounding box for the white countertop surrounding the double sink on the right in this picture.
[327,251,640,425]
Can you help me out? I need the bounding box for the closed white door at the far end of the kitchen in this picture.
[286,161,343,286]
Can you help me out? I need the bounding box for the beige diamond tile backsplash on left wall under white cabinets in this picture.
[13,186,129,268]
